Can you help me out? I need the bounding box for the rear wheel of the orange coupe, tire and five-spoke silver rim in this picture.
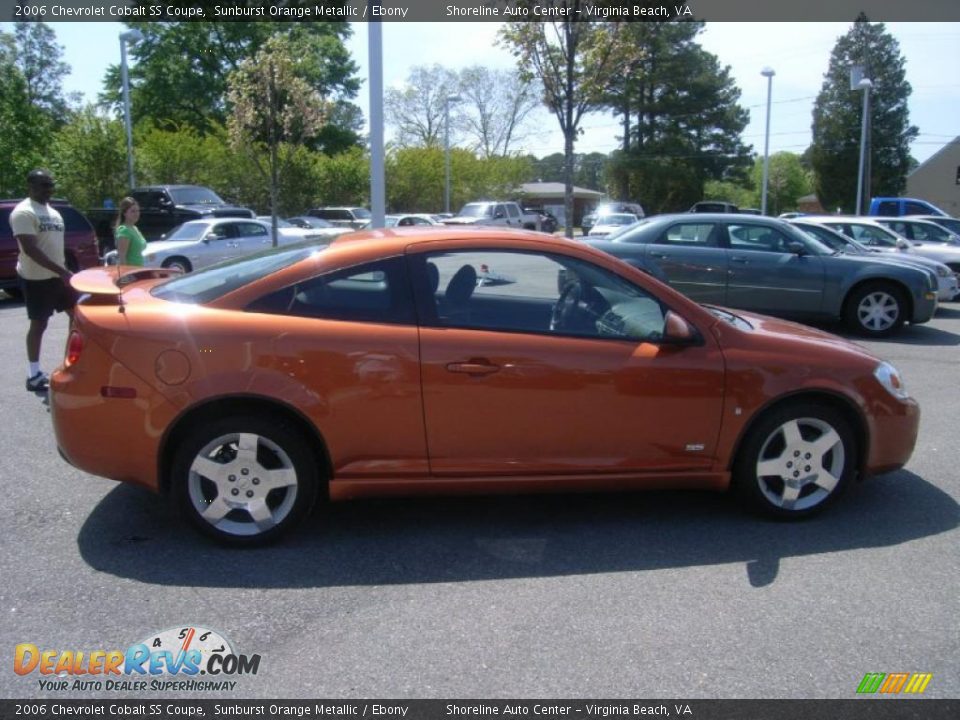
[171,415,320,547]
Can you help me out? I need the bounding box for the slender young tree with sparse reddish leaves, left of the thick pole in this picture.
[227,35,327,246]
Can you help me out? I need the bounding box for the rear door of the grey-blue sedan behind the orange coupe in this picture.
[647,219,728,305]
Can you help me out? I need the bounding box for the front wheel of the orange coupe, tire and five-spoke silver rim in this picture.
[733,403,860,519]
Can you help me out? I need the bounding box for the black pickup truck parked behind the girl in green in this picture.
[87,185,256,254]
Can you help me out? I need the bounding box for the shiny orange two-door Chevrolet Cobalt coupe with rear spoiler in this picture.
[50,228,919,545]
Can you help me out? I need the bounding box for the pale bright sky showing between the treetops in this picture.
[3,22,960,167]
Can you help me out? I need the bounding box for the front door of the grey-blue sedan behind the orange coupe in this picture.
[725,221,826,314]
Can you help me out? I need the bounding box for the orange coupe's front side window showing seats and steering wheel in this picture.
[415,250,666,342]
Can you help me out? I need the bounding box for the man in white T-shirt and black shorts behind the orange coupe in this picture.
[10,170,76,392]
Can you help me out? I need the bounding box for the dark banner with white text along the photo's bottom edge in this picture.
[0,698,960,720]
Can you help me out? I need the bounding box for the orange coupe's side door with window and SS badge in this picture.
[410,246,724,477]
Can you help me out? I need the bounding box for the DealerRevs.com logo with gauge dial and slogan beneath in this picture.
[13,626,260,692]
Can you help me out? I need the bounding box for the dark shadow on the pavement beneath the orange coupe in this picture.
[78,471,960,588]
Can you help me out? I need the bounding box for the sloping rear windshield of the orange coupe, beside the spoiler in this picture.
[151,243,328,305]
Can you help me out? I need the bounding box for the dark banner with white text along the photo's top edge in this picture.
[0,0,960,23]
